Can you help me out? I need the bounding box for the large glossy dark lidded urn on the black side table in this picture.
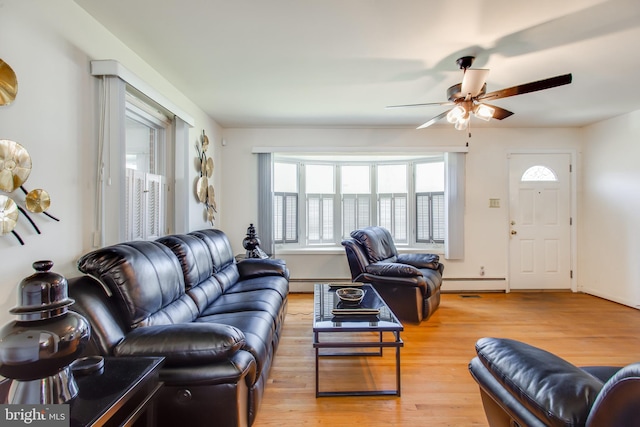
[0,261,90,404]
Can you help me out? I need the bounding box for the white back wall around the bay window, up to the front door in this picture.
[221,127,581,290]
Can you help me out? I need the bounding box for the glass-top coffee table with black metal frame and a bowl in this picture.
[313,283,404,397]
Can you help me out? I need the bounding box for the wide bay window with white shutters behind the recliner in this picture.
[273,154,445,247]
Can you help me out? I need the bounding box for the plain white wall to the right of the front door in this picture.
[579,111,640,308]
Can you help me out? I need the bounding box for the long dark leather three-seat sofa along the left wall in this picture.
[69,229,289,426]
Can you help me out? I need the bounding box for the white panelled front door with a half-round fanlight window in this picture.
[509,154,571,290]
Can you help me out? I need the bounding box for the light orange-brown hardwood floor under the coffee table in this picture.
[254,292,640,427]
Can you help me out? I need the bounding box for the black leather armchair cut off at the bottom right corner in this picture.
[469,338,640,427]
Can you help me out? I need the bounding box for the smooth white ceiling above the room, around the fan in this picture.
[75,0,640,127]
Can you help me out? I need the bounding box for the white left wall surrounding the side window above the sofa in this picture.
[0,0,223,325]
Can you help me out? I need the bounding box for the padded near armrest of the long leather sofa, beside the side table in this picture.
[114,323,245,366]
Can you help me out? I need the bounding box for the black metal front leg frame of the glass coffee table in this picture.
[313,331,404,397]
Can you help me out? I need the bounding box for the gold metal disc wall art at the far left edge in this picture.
[0,59,59,245]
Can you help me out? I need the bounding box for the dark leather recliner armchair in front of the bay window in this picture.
[342,227,444,323]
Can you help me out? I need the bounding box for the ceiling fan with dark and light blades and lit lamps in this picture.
[386,56,572,130]
